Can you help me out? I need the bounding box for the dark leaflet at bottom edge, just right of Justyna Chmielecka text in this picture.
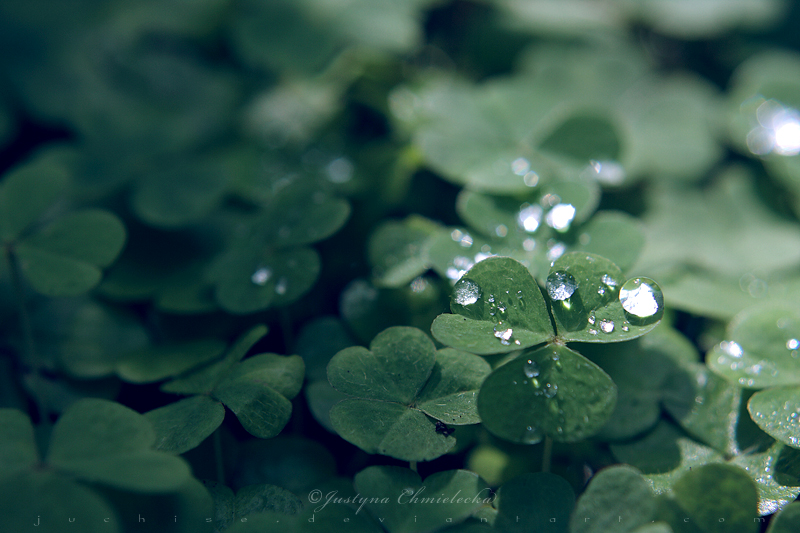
[494,472,575,533]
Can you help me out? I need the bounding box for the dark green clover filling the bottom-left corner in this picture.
[0,399,191,531]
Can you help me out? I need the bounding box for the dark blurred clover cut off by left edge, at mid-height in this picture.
[0,153,125,296]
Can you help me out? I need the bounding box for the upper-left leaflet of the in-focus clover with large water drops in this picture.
[431,257,553,355]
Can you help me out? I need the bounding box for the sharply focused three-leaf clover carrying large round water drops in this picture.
[431,252,664,444]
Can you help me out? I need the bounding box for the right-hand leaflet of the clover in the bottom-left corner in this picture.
[47,399,191,492]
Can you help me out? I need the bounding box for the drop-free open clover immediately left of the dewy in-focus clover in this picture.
[328,326,490,461]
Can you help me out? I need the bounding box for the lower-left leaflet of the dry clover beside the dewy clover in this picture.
[330,398,456,461]
